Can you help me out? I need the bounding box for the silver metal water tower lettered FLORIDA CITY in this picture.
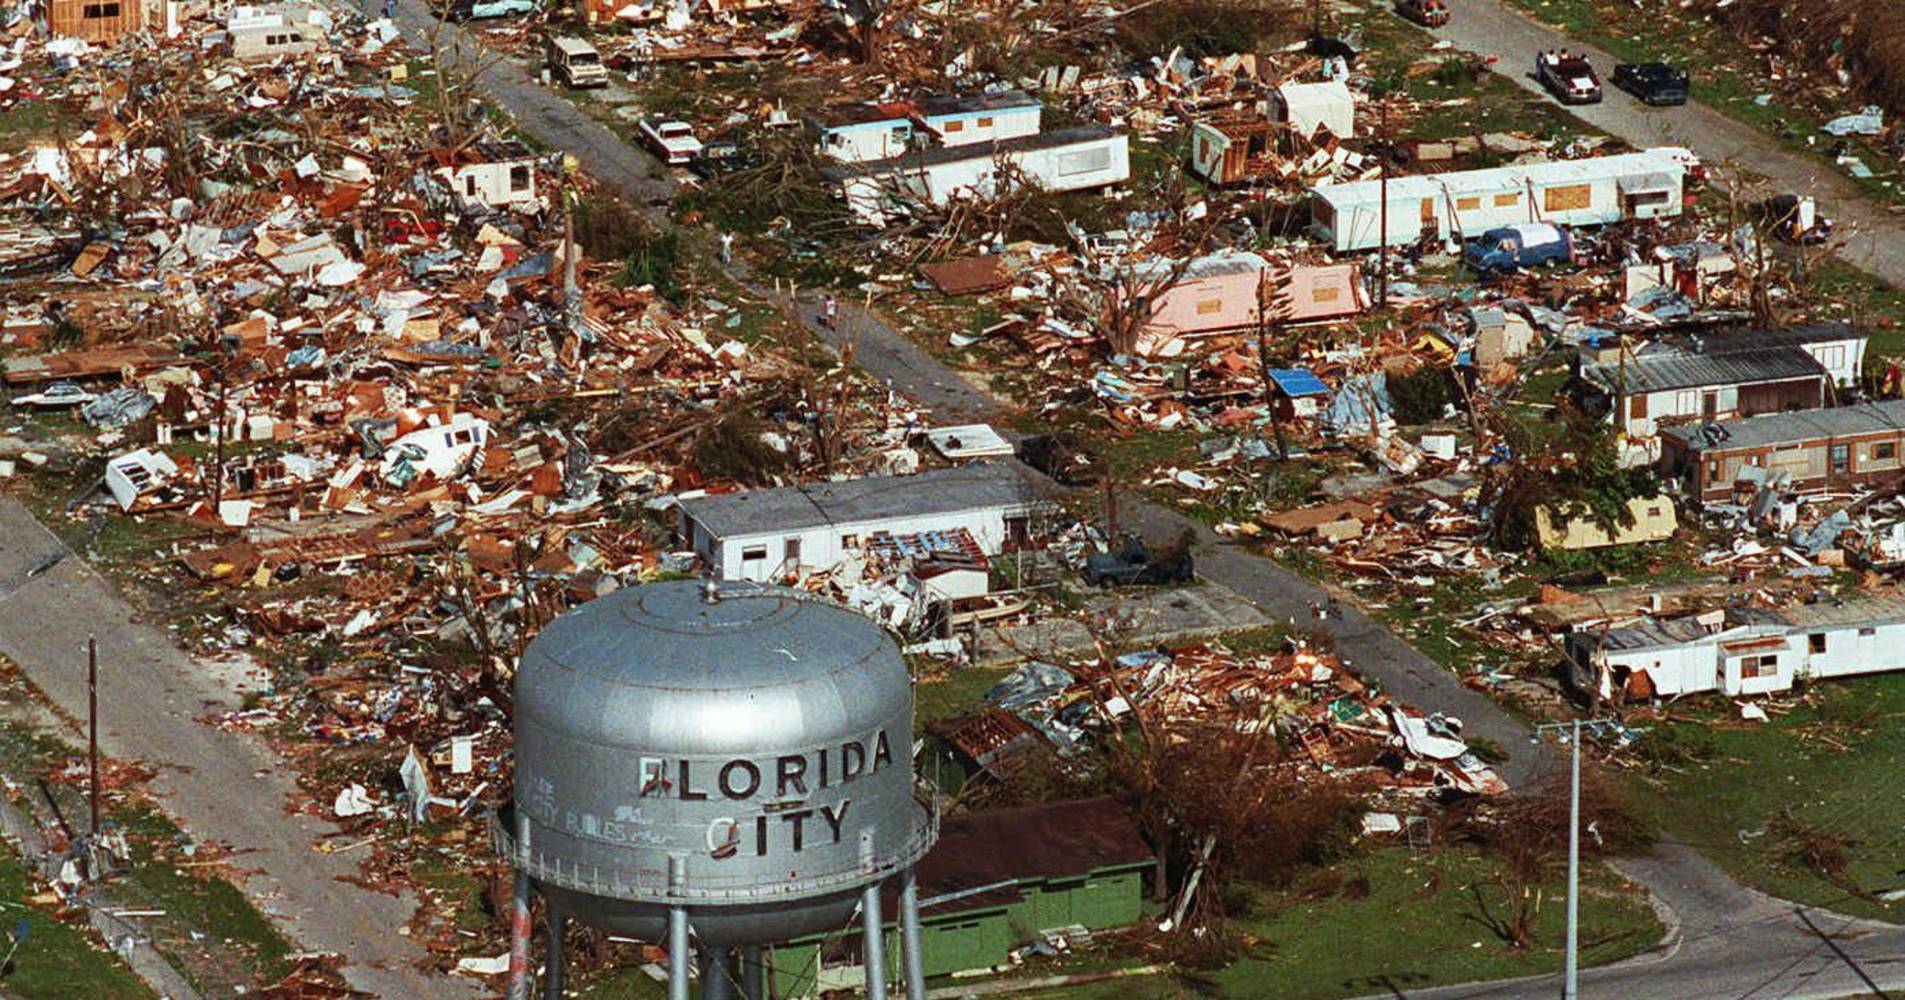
[493,581,937,1000]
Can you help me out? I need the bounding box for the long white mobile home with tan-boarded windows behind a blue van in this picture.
[1311,147,1695,251]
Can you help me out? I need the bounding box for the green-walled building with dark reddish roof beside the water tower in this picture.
[770,798,1153,1000]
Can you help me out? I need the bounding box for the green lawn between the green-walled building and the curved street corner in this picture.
[1031,848,1663,1000]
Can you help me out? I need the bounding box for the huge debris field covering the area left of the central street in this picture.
[0,1,918,967]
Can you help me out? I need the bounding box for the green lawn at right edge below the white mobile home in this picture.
[1638,674,1905,922]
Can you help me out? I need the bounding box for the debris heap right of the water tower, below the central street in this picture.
[928,642,1507,796]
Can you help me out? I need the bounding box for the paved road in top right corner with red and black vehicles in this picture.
[1431,0,1905,288]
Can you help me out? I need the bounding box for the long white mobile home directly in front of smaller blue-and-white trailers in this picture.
[829,126,1132,223]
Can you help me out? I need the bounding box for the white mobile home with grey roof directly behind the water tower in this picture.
[678,463,1046,581]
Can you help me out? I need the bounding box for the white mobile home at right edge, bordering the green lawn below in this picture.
[1568,596,1905,697]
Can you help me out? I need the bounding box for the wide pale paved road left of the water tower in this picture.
[0,497,480,1000]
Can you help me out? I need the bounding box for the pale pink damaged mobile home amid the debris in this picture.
[1145,251,1370,352]
